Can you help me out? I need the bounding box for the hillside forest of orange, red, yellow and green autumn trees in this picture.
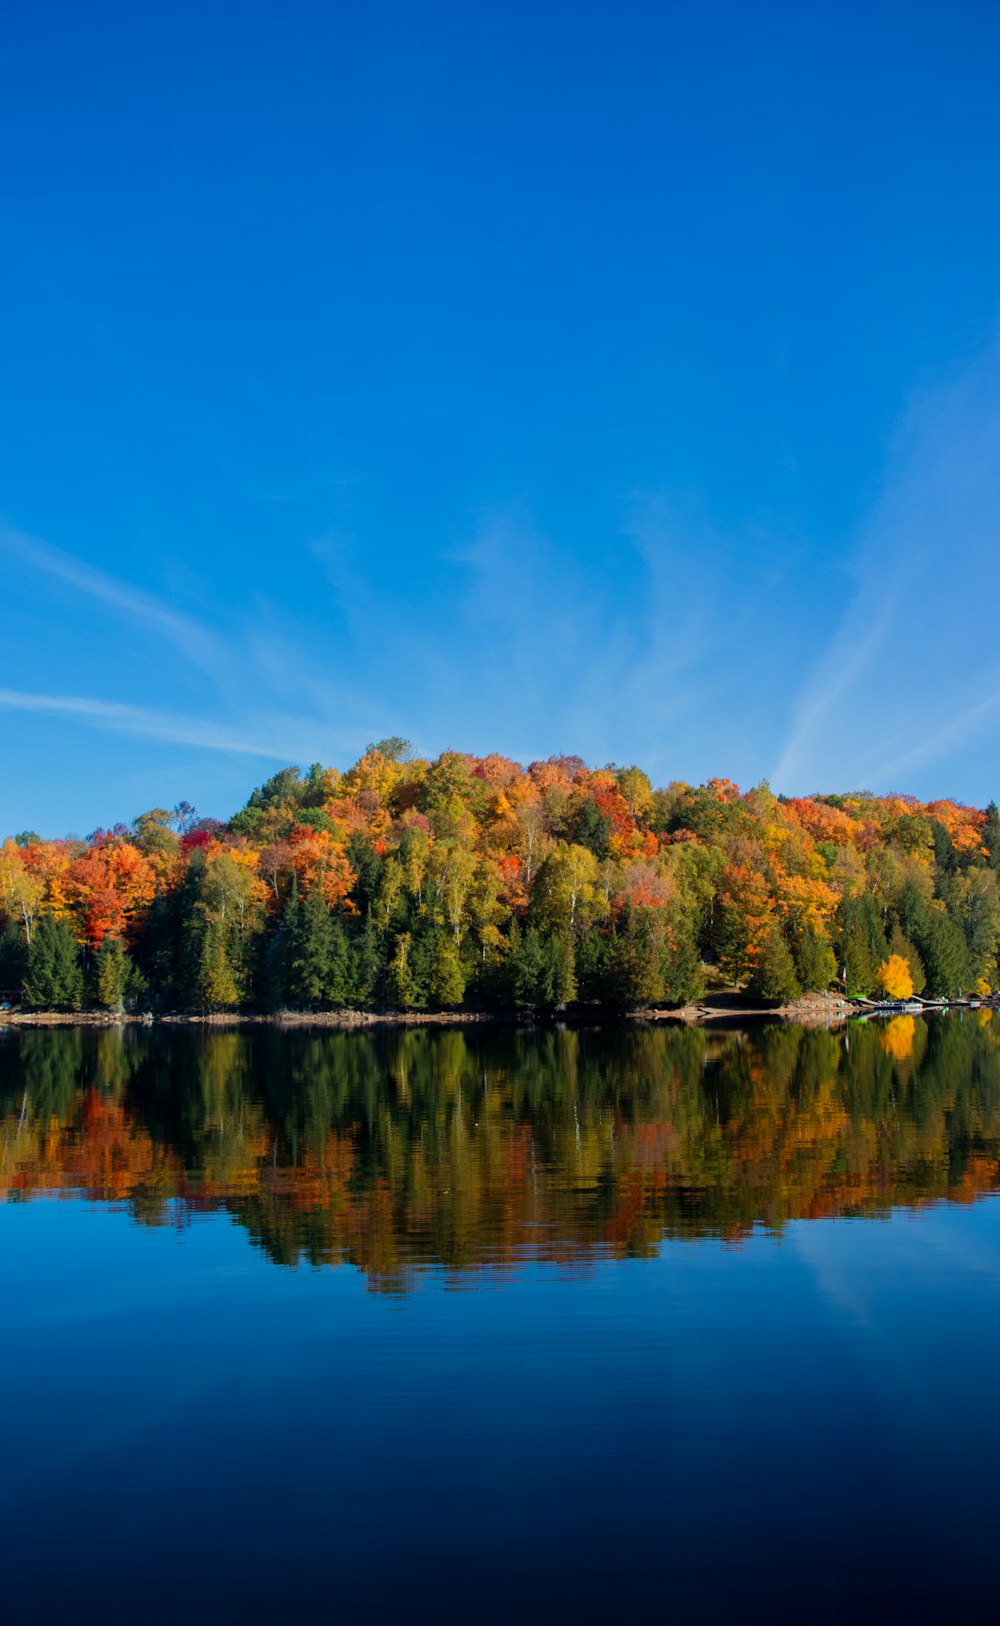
[0,738,1000,1013]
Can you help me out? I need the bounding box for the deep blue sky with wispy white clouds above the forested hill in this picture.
[0,0,1000,834]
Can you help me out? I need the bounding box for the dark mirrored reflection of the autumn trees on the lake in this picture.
[0,1013,1000,1286]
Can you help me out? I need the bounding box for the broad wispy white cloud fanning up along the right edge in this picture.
[772,340,1000,800]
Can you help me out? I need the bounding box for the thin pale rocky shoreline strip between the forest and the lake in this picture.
[0,993,857,1033]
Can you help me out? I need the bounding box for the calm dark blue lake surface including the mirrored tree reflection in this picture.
[0,1015,1000,1623]
